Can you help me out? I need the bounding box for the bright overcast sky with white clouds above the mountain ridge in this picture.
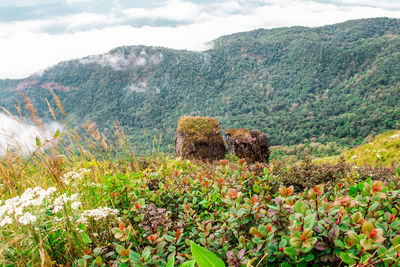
[0,0,400,79]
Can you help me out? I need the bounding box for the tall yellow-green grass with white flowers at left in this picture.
[0,92,146,266]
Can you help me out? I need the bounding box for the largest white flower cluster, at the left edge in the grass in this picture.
[0,187,57,227]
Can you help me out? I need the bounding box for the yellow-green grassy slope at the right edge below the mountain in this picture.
[318,130,400,167]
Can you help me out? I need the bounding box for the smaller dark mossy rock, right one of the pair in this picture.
[225,129,270,163]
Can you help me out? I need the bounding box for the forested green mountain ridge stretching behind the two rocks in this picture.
[0,18,400,152]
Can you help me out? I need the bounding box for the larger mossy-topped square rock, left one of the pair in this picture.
[175,116,226,160]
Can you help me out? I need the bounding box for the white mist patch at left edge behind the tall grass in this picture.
[0,113,62,155]
